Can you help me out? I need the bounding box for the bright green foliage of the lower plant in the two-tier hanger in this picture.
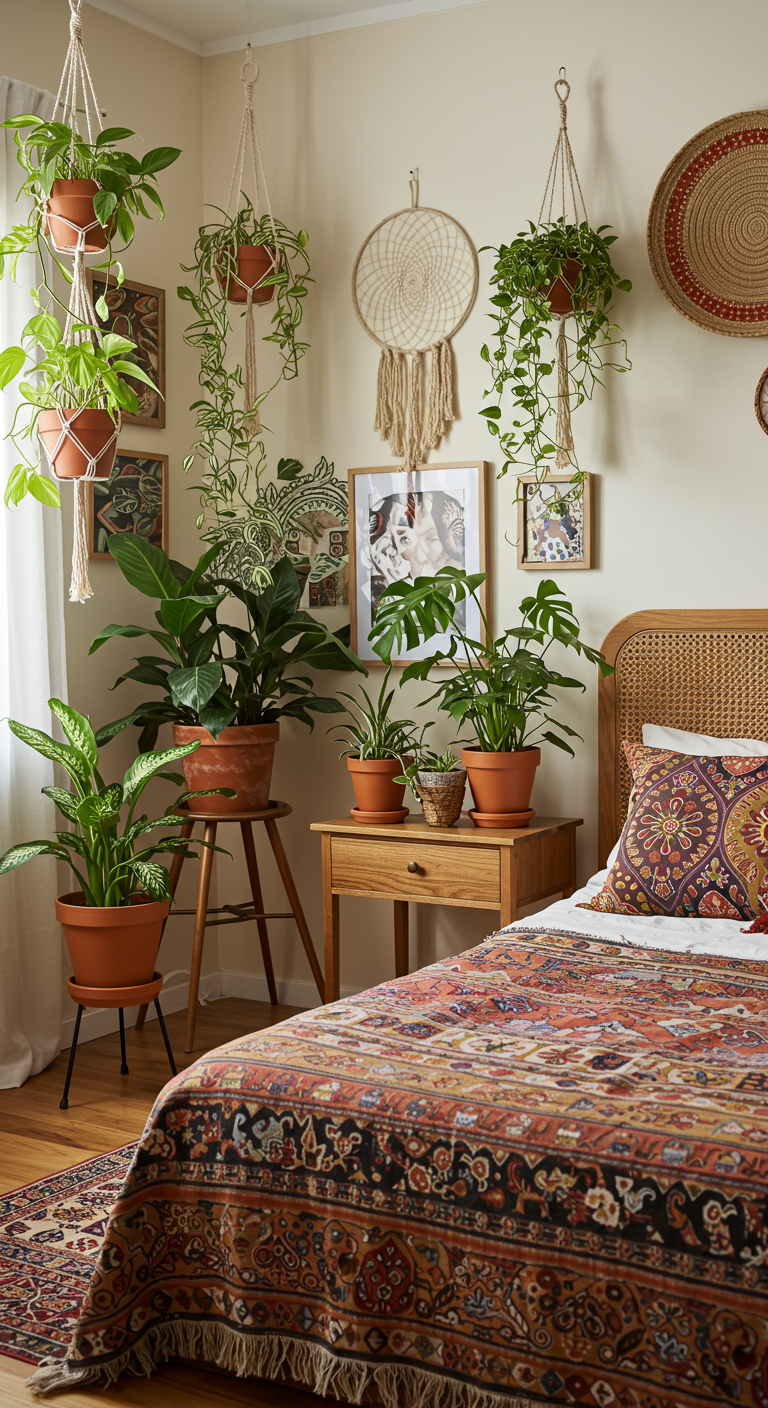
[0,313,155,505]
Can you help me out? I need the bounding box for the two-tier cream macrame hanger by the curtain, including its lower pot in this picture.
[41,0,121,601]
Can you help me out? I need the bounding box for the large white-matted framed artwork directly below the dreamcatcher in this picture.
[349,459,488,665]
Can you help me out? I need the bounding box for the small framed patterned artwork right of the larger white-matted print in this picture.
[517,474,592,572]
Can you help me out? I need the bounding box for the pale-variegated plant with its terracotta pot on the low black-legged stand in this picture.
[0,698,229,988]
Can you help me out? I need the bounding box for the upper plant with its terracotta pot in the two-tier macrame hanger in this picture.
[0,113,182,306]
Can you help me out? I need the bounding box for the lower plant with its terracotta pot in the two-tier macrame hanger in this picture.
[0,313,154,505]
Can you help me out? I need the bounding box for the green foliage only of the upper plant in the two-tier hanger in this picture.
[0,113,182,308]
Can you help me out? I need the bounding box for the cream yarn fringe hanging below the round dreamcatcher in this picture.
[373,338,454,472]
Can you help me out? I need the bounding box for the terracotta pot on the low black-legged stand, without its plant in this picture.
[56,890,171,987]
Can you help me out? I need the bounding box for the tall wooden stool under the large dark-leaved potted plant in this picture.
[137,801,326,1052]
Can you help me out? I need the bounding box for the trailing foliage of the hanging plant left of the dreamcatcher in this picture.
[178,197,311,540]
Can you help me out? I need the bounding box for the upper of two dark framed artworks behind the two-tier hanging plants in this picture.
[87,269,165,431]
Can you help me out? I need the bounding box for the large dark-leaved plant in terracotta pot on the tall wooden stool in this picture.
[90,534,366,812]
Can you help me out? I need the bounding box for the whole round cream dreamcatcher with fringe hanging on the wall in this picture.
[352,170,478,472]
